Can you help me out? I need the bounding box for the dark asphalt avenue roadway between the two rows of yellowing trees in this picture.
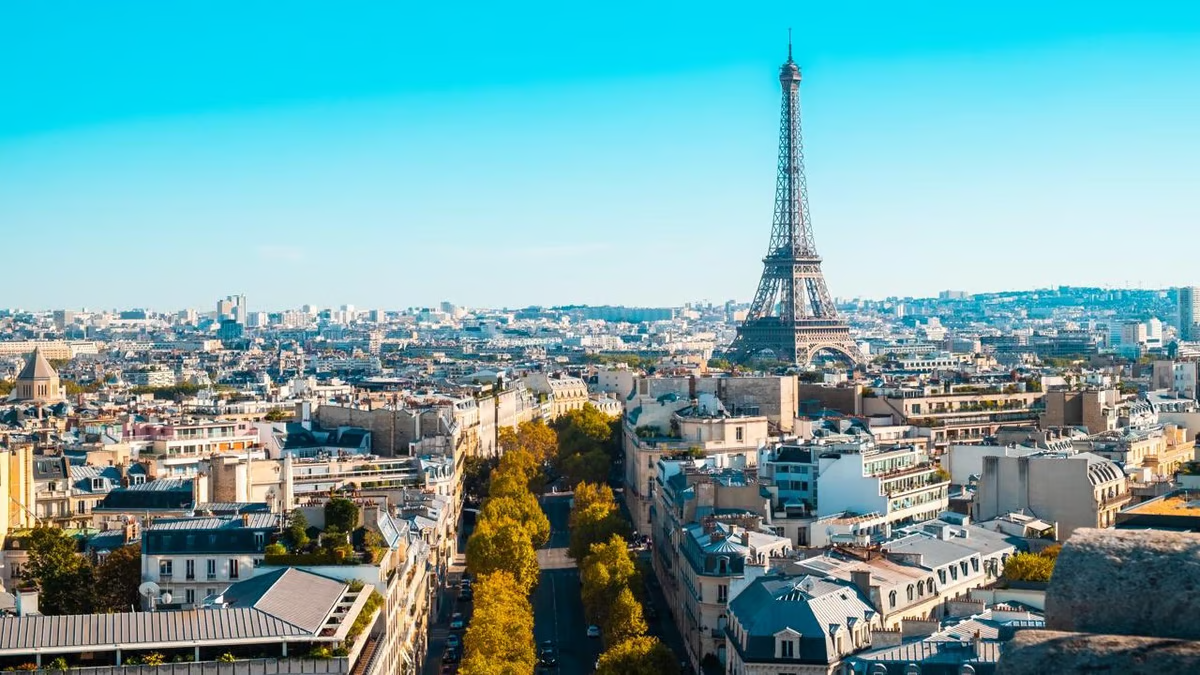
[533,495,601,674]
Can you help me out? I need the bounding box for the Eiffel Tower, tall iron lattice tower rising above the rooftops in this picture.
[730,41,863,365]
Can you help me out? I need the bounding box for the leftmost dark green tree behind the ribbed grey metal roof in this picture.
[23,526,96,615]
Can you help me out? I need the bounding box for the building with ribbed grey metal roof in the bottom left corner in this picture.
[0,569,381,675]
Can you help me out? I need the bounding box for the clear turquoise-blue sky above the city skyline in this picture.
[0,0,1200,309]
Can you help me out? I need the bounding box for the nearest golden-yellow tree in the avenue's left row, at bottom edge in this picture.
[461,572,536,675]
